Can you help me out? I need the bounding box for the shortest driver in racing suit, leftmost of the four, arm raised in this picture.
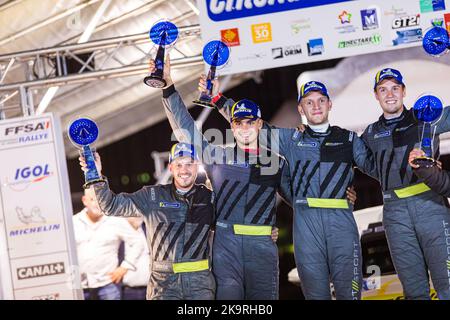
[80,143,215,300]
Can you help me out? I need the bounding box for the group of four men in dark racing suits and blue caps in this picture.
[80,59,450,299]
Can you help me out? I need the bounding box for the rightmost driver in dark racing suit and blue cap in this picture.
[362,68,450,299]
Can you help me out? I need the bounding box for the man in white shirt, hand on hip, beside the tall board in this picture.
[73,189,145,300]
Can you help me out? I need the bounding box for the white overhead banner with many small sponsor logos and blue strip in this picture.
[197,0,450,75]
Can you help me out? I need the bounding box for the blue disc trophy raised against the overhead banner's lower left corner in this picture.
[193,40,230,108]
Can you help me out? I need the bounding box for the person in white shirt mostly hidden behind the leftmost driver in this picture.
[122,217,150,300]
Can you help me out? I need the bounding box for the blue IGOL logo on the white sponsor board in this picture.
[3,164,53,191]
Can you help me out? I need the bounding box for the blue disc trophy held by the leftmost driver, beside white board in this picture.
[67,118,105,189]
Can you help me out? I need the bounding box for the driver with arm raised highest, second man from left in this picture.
[150,58,291,300]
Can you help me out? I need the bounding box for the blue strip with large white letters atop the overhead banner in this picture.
[206,0,351,21]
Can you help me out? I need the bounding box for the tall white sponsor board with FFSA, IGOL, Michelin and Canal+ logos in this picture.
[0,114,82,299]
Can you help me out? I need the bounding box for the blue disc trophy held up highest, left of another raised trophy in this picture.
[144,21,178,88]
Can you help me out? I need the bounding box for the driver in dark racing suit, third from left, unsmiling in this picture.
[207,79,374,300]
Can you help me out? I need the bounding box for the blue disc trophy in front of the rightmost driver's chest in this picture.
[412,94,443,168]
